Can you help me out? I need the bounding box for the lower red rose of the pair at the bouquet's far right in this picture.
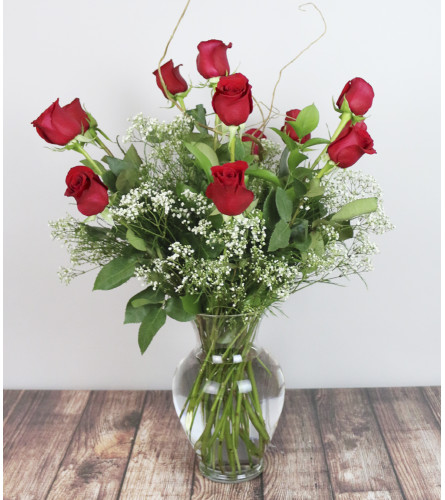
[328,122,377,168]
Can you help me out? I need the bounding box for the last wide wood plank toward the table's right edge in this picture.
[369,387,440,500]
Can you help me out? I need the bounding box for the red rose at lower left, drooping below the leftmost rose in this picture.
[65,165,108,216]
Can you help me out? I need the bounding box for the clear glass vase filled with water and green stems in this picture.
[173,314,284,483]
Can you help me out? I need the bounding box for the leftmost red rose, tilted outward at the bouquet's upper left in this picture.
[31,97,90,146]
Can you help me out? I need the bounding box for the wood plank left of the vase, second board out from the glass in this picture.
[46,391,145,500]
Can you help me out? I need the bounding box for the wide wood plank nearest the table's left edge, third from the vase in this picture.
[3,391,89,500]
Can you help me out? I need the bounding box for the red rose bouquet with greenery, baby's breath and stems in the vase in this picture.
[33,17,392,482]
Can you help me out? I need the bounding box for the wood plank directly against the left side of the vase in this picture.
[119,391,195,500]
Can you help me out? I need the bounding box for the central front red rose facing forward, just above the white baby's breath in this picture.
[206,161,254,215]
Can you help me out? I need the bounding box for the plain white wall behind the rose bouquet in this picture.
[4,0,440,389]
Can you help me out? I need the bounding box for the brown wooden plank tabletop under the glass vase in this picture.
[3,387,440,500]
